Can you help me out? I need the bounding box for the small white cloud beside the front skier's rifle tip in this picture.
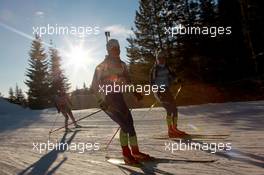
[104,24,133,37]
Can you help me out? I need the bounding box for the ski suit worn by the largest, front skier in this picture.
[92,56,137,146]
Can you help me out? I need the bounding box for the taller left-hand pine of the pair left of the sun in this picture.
[25,35,50,109]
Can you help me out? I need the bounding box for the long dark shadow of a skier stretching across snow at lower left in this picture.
[19,131,78,175]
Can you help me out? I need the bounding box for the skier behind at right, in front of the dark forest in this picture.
[150,51,188,138]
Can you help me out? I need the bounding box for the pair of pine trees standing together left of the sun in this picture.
[25,35,70,109]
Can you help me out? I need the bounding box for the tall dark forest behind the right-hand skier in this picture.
[127,0,264,84]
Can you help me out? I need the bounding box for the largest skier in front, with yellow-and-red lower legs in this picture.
[92,39,150,164]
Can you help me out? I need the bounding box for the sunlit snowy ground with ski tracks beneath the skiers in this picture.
[0,99,264,175]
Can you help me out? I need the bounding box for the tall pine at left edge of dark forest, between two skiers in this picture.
[126,0,168,84]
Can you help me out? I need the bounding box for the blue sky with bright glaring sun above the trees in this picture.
[0,0,138,96]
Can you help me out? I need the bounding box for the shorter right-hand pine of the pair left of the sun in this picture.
[49,41,70,99]
